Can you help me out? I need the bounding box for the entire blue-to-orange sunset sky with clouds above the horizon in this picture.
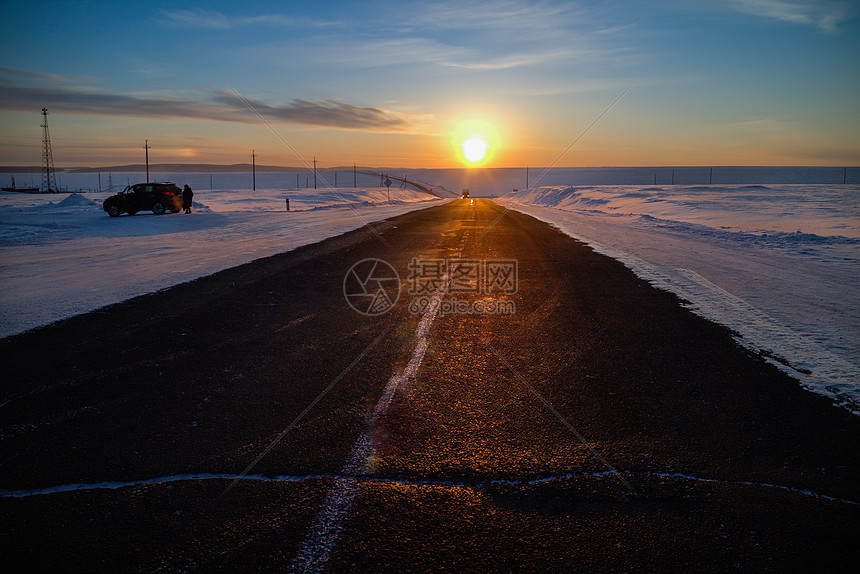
[0,0,860,168]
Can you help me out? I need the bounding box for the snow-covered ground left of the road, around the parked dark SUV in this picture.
[0,188,440,337]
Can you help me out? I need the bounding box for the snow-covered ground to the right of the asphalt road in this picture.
[498,185,860,413]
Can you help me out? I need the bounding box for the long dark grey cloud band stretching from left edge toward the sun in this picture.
[0,82,427,132]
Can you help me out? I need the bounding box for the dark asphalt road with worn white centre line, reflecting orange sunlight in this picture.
[0,199,860,572]
